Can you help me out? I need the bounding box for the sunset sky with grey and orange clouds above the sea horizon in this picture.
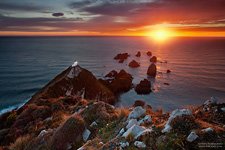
[0,0,225,37]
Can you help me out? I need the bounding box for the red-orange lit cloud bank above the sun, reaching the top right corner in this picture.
[81,0,225,24]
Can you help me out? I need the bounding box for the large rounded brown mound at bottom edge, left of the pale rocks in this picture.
[51,115,85,150]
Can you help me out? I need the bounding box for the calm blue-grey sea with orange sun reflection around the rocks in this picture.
[0,37,225,113]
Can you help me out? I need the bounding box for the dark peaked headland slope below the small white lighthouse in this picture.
[30,65,115,104]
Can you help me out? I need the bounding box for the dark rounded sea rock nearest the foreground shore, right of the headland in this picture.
[135,79,151,94]
